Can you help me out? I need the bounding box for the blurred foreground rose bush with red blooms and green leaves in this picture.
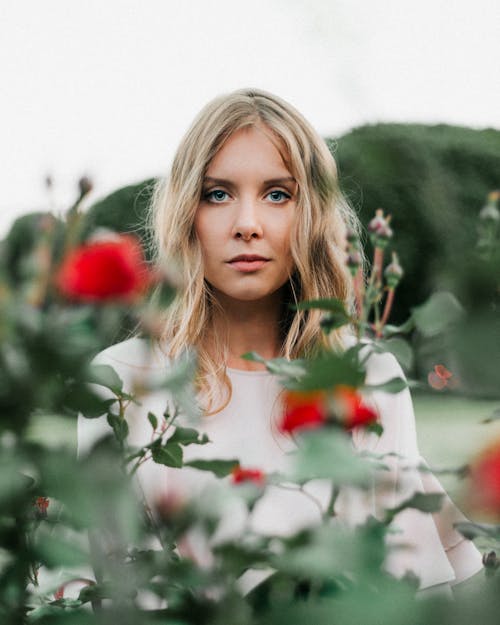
[0,179,500,625]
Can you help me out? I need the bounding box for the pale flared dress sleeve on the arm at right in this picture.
[353,353,482,589]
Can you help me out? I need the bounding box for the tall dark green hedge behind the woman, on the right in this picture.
[327,124,500,322]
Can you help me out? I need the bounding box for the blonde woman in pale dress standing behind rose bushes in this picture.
[80,89,481,590]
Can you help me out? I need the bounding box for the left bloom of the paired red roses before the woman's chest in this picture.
[279,391,326,434]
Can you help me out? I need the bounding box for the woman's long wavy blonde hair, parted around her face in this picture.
[151,89,359,414]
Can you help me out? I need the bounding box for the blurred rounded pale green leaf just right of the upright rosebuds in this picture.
[411,291,464,337]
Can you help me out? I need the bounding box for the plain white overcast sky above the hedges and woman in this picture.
[0,0,500,235]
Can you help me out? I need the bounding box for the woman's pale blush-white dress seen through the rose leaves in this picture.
[78,338,482,590]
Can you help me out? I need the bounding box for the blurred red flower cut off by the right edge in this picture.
[467,441,500,522]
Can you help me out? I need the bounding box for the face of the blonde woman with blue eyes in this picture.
[194,126,297,302]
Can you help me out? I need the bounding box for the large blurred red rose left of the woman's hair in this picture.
[56,235,153,302]
